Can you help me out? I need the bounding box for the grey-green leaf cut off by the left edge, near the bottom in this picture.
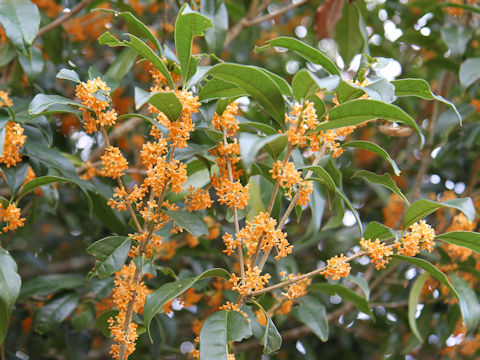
[0,248,22,344]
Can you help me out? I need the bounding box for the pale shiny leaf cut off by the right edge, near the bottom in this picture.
[450,274,480,334]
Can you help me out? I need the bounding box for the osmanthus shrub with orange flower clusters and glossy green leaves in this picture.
[0,0,480,360]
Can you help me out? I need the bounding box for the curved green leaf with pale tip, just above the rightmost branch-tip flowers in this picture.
[403,198,475,229]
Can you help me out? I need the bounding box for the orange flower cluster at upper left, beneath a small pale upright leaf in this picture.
[75,77,117,134]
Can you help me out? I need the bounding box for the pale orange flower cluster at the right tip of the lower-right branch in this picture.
[394,220,435,256]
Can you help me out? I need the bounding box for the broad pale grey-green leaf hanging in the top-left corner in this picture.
[0,0,40,58]
